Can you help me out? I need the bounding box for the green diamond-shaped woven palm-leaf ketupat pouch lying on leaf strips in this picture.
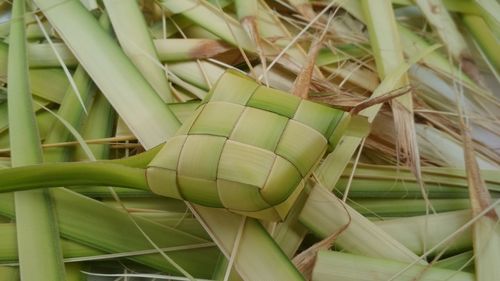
[147,71,343,220]
